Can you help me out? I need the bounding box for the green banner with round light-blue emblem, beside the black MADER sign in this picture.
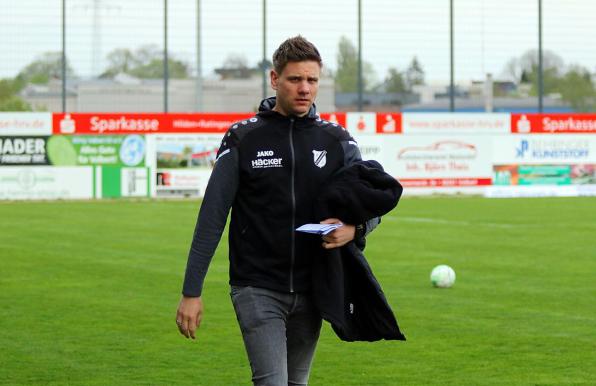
[47,135,146,166]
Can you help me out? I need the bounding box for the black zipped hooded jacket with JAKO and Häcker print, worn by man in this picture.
[182,98,370,296]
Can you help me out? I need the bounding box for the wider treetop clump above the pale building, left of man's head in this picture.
[101,45,190,79]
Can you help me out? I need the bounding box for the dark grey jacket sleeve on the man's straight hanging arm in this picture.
[182,132,239,297]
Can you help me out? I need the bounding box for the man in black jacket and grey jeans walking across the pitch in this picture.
[176,36,376,385]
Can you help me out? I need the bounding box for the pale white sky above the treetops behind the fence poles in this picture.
[0,0,596,83]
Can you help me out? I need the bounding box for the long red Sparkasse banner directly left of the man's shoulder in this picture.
[52,113,254,134]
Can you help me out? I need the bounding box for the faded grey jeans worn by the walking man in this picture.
[230,286,321,386]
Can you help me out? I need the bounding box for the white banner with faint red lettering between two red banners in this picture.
[402,113,511,135]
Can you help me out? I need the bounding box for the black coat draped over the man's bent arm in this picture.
[312,161,406,341]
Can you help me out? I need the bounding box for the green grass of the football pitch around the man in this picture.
[0,197,596,386]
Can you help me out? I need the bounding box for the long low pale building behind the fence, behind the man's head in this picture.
[20,74,335,112]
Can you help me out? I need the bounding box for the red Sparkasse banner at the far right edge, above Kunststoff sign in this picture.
[511,114,596,134]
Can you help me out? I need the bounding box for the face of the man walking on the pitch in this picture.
[271,60,321,117]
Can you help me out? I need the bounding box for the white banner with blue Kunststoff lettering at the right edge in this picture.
[493,134,596,165]
